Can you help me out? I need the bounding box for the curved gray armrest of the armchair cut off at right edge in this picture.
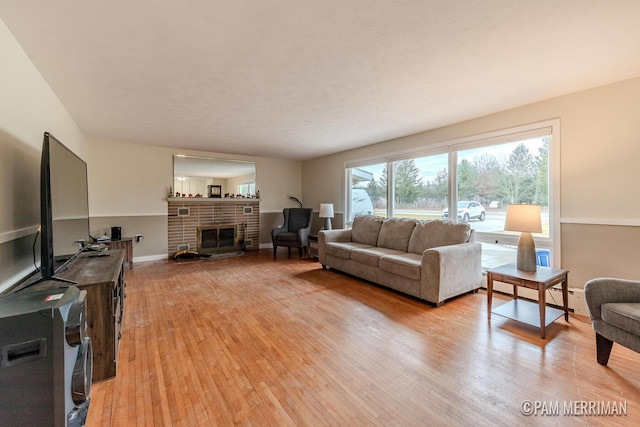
[584,277,640,320]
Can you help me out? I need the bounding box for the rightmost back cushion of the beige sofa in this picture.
[408,219,471,254]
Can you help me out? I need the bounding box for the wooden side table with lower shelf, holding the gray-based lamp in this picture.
[487,263,569,339]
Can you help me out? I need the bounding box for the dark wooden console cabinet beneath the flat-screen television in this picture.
[57,249,126,381]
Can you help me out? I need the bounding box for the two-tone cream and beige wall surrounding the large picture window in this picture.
[303,78,640,287]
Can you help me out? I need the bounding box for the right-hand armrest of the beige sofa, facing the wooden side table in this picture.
[420,242,482,304]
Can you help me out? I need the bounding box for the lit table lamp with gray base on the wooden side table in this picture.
[504,205,542,271]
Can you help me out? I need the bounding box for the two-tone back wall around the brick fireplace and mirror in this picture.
[89,141,302,261]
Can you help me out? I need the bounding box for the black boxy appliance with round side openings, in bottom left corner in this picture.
[0,286,93,427]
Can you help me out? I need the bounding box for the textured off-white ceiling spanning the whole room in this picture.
[0,0,640,160]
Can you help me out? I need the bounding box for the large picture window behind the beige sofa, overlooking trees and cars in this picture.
[346,120,560,266]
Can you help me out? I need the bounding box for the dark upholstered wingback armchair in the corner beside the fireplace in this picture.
[271,208,313,258]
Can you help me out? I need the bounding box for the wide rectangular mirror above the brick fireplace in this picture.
[173,155,256,198]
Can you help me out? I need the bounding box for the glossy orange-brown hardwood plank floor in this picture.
[87,250,640,426]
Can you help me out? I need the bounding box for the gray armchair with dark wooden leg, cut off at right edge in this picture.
[584,278,640,365]
